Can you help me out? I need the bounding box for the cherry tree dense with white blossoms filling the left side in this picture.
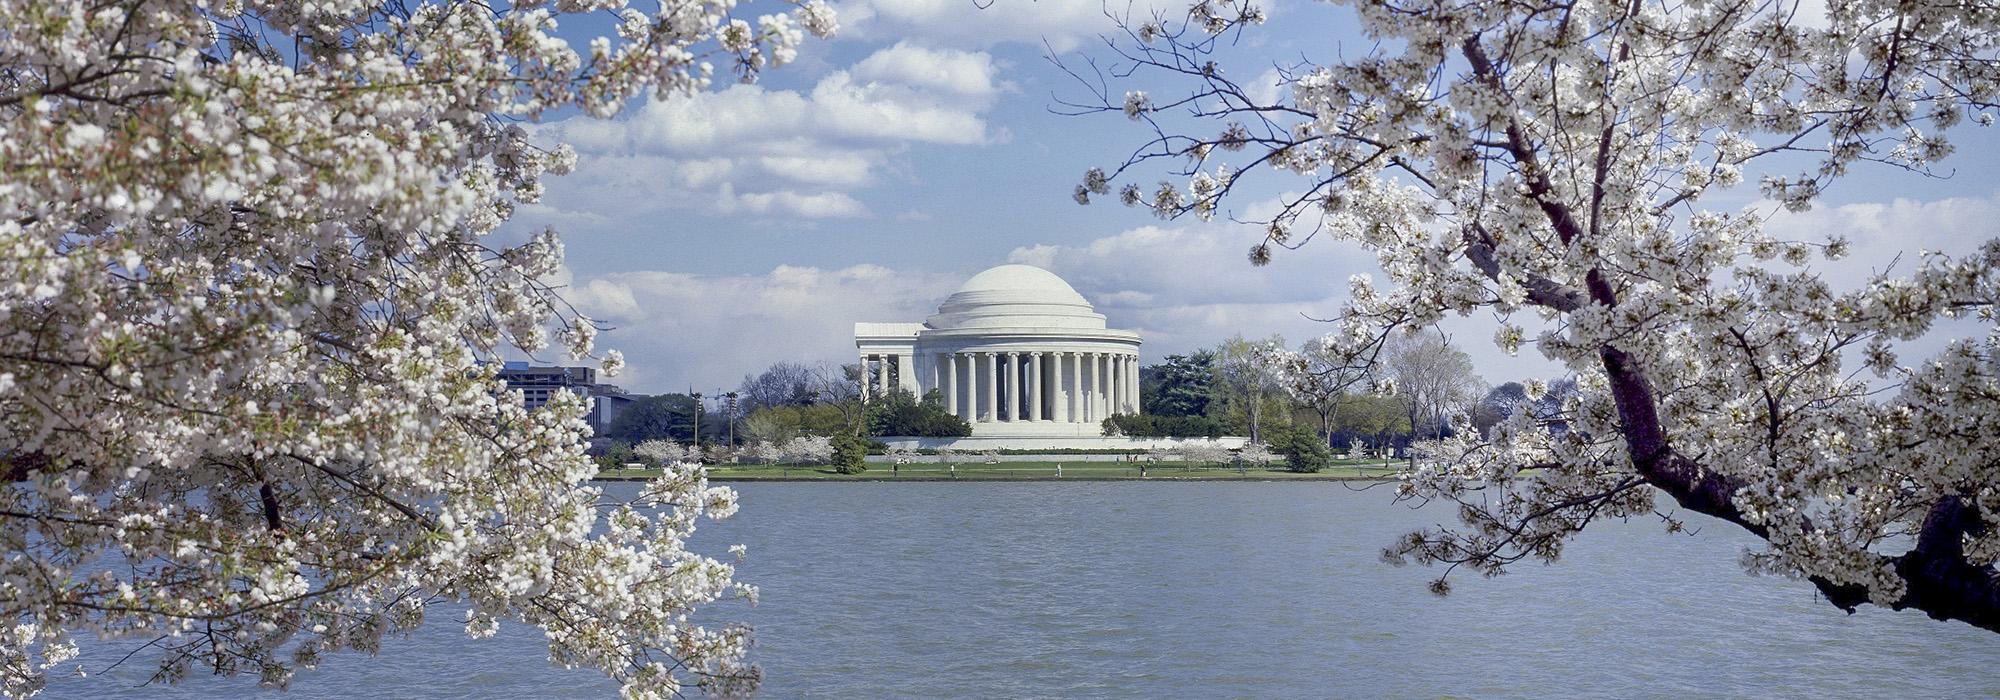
[0,0,834,698]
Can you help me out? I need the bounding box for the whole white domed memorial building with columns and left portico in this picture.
[854,264,1140,438]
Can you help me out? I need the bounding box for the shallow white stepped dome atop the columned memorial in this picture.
[924,264,1104,330]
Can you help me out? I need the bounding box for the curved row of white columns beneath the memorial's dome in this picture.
[928,350,1138,422]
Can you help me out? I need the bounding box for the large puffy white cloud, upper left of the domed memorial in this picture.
[522,42,1012,230]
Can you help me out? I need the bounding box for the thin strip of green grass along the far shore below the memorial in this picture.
[598,462,1400,482]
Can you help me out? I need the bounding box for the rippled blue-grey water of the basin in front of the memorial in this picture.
[46,482,2000,698]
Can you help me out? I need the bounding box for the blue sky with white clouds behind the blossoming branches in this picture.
[502,0,2000,392]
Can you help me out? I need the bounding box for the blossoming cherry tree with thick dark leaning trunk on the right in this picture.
[1068,0,2000,630]
